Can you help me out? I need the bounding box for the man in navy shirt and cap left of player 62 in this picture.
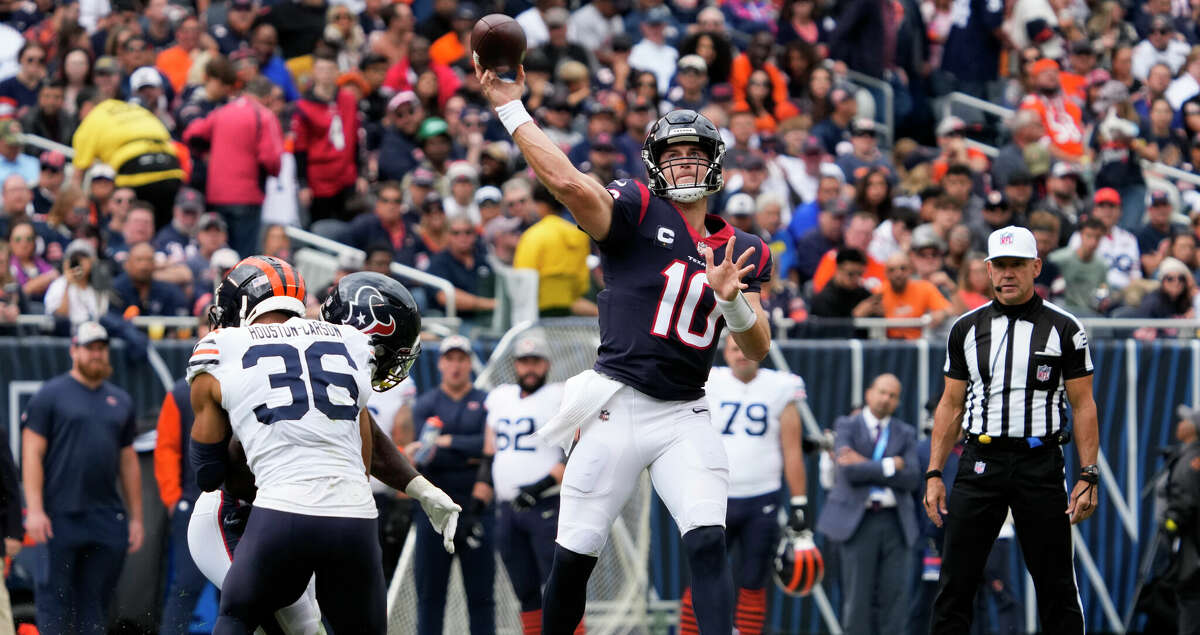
[404,335,496,635]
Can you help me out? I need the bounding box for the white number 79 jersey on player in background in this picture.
[704,366,805,498]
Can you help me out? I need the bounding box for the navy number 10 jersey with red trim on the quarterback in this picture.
[595,180,772,401]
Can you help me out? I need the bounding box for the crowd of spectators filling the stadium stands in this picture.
[0,0,1200,337]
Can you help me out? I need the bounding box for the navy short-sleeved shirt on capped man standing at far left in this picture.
[22,373,137,513]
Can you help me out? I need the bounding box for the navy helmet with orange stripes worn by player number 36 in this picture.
[209,256,307,329]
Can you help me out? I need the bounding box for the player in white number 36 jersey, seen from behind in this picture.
[188,257,458,634]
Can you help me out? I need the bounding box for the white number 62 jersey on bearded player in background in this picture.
[484,383,563,501]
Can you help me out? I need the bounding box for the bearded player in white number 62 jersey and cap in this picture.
[480,334,566,635]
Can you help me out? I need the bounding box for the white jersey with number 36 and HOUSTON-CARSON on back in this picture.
[187,317,377,519]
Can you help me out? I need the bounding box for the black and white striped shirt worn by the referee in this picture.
[943,295,1092,437]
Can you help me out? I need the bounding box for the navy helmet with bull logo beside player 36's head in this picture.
[320,271,421,393]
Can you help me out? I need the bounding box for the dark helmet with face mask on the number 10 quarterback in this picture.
[642,110,725,203]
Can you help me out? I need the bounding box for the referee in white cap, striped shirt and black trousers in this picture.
[925,227,1099,635]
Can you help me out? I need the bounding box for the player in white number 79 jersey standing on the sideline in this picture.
[679,337,808,635]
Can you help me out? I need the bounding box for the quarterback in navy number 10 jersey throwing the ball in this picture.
[475,57,772,635]
